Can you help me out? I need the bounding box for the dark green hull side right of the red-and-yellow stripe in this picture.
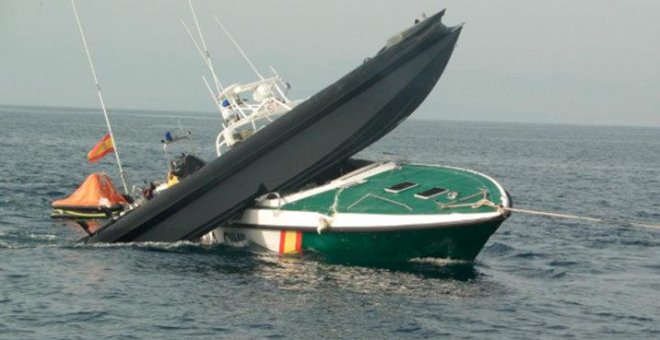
[302,220,502,264]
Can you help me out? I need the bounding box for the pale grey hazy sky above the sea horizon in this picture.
[0,0,660,126]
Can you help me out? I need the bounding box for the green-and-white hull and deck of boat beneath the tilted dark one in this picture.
[202,160,511,263]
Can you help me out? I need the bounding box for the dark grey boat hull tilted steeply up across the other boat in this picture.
[87,13,460,243]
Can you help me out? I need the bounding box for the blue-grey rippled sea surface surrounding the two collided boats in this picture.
[0,107,660,339]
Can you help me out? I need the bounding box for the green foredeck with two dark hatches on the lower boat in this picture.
[278,163,509,214]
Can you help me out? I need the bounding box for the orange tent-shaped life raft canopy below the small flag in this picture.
[52,172,128,210]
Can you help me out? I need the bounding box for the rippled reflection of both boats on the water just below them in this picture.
[42,242,493,300]
